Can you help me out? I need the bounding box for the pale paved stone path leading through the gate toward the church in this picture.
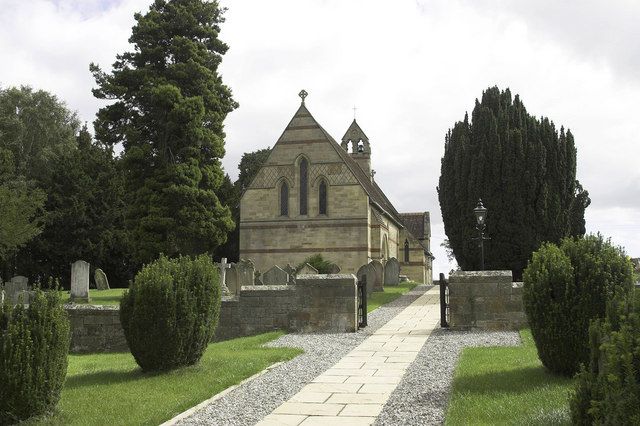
[258,287,440,426]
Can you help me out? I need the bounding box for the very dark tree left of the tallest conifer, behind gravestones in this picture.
[17,125,132,285]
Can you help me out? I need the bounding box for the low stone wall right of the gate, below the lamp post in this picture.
[449,271,527,330]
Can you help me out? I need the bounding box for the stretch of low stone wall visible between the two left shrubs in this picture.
[64,304,129,353]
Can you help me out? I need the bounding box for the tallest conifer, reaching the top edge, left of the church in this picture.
[91,0,237,264]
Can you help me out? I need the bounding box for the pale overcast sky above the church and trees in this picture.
[0,0,640,276]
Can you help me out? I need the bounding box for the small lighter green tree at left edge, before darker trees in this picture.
[0,148,45,264]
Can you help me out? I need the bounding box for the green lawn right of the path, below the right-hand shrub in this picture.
[446,330,573,425]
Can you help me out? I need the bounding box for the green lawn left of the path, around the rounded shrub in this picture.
[29,332,302,425]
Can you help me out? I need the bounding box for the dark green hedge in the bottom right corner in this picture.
[570,290,640,425]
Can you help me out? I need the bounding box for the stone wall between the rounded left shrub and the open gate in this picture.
[215,274,358,340]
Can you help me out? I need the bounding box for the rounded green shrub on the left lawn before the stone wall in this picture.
[120,255,221,371]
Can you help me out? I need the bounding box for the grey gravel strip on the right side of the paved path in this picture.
[374,328,520,425]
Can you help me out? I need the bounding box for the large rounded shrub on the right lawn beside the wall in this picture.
[523,235,633,376]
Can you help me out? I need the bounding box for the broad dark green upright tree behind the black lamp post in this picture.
[438,87,590,279]
